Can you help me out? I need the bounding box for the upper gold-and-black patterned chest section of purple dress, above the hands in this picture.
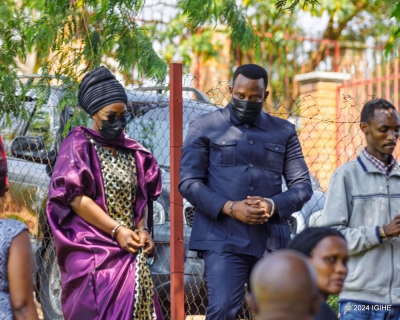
[92,140,137,229]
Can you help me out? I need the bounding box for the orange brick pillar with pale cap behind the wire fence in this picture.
[296,72,348,190]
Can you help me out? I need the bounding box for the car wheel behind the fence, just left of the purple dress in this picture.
[39,241,64,320]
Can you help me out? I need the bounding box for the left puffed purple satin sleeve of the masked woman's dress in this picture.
[48,132,95,224]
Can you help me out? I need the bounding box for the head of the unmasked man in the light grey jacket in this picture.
[360,99,400,163]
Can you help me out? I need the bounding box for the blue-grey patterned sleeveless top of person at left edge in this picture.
[0,219,28,320]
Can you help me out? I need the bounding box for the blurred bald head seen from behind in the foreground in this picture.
[248,250,320,320]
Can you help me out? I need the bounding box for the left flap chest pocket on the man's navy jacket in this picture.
[210,139,236,167]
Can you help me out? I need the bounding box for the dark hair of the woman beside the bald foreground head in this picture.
[287,227,346,257]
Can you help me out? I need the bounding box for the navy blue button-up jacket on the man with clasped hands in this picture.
[179,105,312,257]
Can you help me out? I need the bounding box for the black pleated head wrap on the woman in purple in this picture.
[78,67,128,115]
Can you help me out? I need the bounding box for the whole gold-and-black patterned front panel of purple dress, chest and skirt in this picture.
[90,139,157,320]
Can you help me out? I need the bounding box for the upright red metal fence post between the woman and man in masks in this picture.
[169,63,185,320]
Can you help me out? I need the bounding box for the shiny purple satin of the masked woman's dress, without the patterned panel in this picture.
[47,127,163,320]
